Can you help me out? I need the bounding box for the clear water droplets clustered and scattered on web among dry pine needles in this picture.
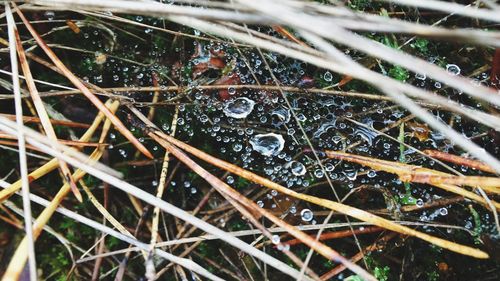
[99,25,481,231]
